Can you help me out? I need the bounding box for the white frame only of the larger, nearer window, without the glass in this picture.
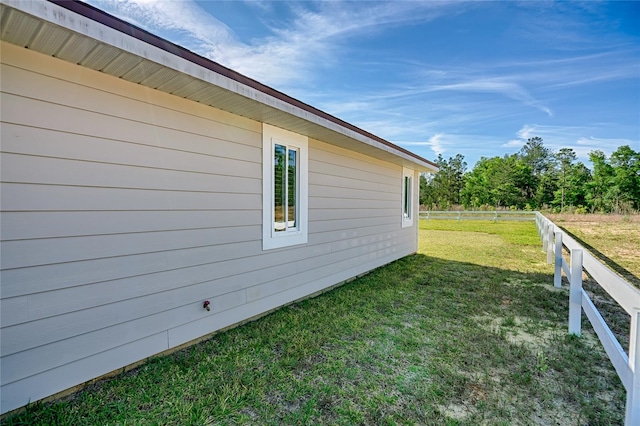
[262,123,309,250]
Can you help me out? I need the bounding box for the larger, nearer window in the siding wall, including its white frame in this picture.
[262,124,308,250]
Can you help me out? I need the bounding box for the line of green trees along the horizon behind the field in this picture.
[420,137,640,214]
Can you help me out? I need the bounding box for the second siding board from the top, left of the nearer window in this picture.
[1,59,255,145]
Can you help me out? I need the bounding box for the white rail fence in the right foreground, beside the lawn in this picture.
[535,213,640,426]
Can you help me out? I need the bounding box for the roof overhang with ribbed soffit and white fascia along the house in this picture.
[0,0,438,172]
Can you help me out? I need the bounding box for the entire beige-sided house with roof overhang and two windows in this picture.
[0,0,437,413]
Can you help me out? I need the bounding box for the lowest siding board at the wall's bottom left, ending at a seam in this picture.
[0,332,168,412]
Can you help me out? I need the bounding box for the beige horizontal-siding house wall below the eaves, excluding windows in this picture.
[0,42,417,412]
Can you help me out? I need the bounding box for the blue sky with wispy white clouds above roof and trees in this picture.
[82,0,640,169]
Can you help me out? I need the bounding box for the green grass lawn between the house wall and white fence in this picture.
[5,221,625,425]
